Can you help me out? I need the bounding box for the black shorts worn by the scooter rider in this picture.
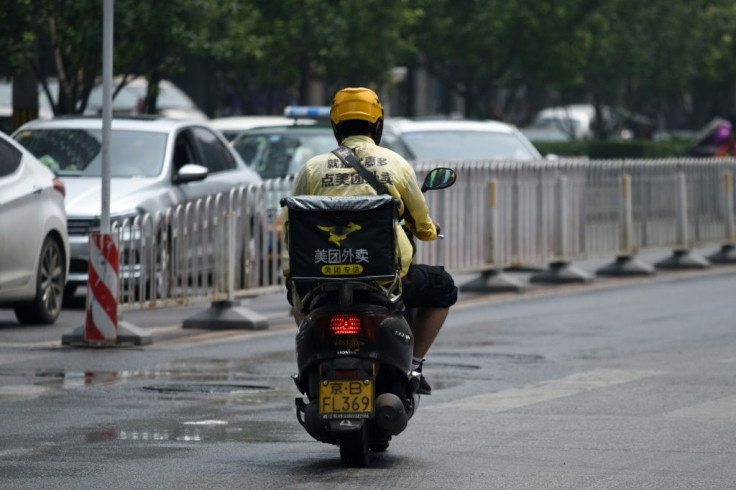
[286,264,457,308]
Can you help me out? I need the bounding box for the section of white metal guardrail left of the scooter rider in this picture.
[112,178,292,310]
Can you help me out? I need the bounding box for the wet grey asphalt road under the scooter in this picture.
[0,258,736,489]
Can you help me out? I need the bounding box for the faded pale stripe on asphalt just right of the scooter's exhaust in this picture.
[428,369,662,413]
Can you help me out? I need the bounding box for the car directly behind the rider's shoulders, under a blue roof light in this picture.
[232,124,414,179]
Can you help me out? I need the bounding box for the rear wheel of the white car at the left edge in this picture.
[14,237,66,325]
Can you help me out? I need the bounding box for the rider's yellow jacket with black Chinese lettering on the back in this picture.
[283,136,437,277]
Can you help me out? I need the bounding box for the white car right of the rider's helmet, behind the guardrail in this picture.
[384,119,542,161]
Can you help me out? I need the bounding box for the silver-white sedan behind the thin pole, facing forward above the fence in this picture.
[13,117,261,296]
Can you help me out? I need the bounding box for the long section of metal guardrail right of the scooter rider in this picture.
[417,158,736,271]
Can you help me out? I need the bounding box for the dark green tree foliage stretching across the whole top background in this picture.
[0,0,736,125]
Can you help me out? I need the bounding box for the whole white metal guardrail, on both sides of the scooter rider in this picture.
[113,158,736,310]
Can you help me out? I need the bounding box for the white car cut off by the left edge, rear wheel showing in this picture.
[0,132,70,325]
